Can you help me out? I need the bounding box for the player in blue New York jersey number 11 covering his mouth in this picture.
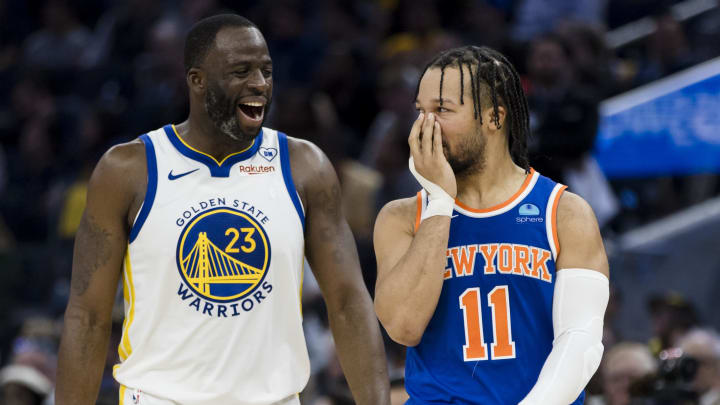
[374,47,608,405]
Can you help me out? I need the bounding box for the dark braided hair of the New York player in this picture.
[415,45,530,172]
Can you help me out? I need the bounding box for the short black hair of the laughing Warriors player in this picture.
[184,14,257,73]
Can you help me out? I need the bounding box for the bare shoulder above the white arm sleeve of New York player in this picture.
[557,191,609,276]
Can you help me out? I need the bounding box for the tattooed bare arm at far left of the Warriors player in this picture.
[55,142,145,405]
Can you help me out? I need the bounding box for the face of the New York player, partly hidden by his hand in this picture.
[415,66,491,176]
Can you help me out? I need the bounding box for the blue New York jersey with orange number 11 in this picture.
[405,170,584,405]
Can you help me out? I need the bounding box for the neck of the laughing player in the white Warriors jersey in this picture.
[175,111,254,162]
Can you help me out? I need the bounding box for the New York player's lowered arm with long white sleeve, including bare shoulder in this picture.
[520,193,609,405]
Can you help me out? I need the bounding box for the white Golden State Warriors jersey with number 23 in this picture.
[113,125,310,405]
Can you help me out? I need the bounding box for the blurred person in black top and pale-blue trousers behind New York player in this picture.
[527,34,618,228]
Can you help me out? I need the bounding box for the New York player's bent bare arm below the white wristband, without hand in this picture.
[373,198,450,346]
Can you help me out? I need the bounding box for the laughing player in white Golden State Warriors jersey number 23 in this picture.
[56,15,389,405]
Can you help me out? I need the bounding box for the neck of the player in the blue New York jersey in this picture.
[457,138,527,209]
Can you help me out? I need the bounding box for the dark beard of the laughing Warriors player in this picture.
[205,83,270,141]
